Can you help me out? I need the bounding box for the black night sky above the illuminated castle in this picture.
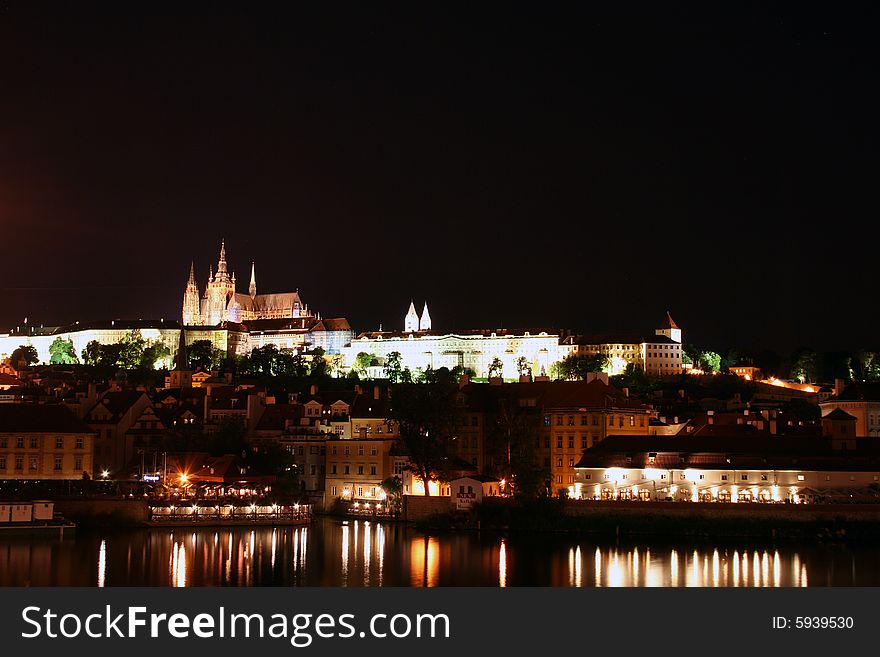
[0,1,880,353]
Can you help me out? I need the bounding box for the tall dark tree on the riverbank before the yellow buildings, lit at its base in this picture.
[390,383,461,495]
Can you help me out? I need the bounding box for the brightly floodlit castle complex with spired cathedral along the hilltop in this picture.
[0,241,684,378]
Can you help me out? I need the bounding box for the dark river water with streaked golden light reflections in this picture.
[0,518,880,587]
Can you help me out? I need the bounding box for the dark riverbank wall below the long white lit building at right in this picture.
[415,500,880,540]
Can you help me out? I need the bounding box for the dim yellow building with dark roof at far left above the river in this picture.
[0,404,95,480]
